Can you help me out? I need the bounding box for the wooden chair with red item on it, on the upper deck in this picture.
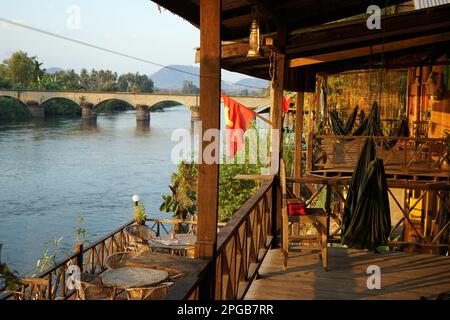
[280,159,328,271]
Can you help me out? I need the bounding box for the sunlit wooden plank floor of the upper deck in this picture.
[245,248,450,300]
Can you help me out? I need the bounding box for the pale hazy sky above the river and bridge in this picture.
[0,0,246,82]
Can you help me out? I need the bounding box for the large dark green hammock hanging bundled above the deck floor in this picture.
[342,139,391,250]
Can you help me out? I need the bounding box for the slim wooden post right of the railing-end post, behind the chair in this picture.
[294,92,305,198]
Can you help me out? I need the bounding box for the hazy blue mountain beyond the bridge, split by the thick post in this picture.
[150,65,268,93]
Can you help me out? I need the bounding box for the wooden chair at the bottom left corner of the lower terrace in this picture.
[13,276,52,300]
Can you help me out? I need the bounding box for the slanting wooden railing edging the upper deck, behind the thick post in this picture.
[184,177,275,300]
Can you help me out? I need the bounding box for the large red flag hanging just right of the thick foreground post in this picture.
[221,93,255,158]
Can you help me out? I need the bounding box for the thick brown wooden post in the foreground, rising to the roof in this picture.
[195,0,222,298]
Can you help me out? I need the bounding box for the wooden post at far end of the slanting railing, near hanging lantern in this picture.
[270,23,286,246]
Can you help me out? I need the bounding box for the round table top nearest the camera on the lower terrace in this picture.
[102,267,169,288]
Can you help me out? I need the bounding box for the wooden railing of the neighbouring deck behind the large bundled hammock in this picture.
[307,135,450,174]
